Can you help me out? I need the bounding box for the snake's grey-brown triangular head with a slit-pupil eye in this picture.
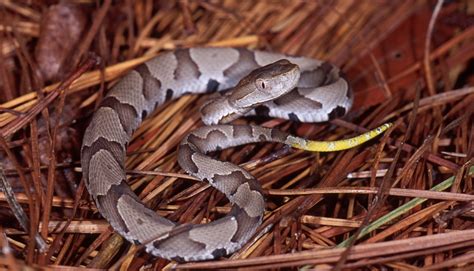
[229,59,300,110]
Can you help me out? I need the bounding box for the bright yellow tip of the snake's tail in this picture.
[287,123,393,152]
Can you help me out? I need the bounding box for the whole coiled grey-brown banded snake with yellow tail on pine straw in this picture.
[81,48,389,261]
